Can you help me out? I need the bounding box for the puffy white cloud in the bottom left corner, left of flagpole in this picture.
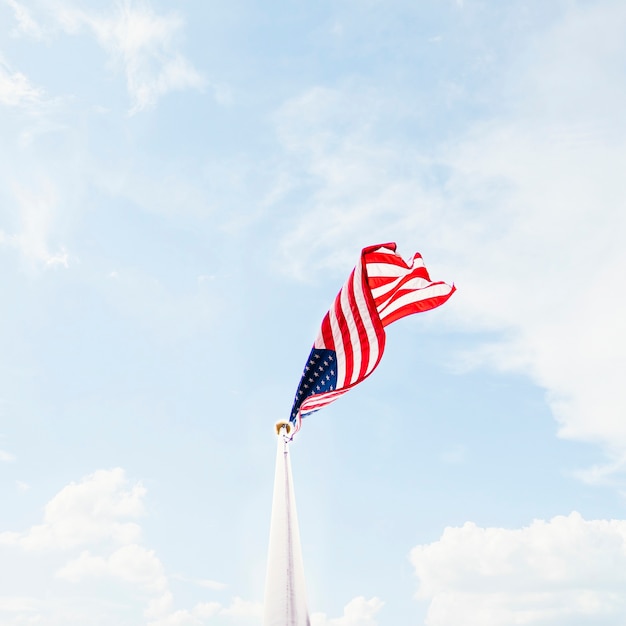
[0,468,261,626]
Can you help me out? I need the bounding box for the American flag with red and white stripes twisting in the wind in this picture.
[289,243,455,431]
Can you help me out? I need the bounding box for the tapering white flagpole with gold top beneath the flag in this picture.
[263,422,310,626]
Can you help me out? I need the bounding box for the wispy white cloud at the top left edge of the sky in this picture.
[50,0,205,113]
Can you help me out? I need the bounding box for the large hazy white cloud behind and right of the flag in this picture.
[277,2,626,458]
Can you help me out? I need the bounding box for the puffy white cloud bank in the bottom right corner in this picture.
[411,512,626,626]
